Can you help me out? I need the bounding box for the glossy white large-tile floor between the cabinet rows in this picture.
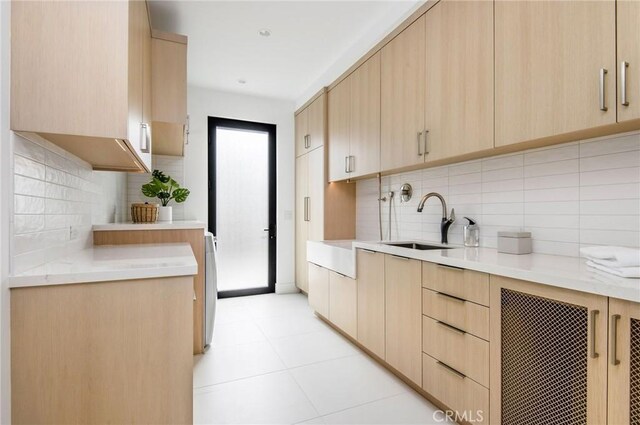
[193,294,442,424]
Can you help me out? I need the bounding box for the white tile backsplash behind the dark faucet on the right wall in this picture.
[356,133,640,256]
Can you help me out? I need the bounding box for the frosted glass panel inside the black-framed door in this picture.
[215,127,269,291]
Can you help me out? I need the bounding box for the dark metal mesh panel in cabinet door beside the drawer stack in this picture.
[501,288,588,425]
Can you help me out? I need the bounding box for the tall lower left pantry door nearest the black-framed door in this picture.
[296,155,309,292]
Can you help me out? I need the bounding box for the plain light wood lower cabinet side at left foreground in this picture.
[11,276,193,424]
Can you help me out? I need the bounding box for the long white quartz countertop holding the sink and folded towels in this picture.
[307,241,640,302]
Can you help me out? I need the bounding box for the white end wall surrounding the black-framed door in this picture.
[184,86,295,292]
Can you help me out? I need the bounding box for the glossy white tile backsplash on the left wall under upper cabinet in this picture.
[11,134,127,273]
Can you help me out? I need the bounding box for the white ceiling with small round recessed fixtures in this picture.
[150,0,422,101]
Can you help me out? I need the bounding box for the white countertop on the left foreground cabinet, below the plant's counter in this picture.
[7,243,198,288]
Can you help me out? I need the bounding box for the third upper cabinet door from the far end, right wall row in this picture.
[380,15,425,171]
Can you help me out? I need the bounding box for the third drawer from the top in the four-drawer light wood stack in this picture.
[422,316,489,387]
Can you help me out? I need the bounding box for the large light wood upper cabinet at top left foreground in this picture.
[11,1,151,171]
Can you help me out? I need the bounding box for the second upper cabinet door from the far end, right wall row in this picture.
[349,53,380,177]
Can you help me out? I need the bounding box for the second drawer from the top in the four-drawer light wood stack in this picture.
[422,288,489,341]
